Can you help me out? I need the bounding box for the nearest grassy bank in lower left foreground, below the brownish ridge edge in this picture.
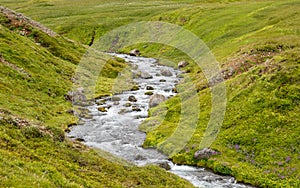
[0,114,191,187]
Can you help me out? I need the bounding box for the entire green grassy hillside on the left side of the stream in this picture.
[0,6,191,187]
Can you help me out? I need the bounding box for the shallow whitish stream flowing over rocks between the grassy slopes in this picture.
[68,54,253,188]
